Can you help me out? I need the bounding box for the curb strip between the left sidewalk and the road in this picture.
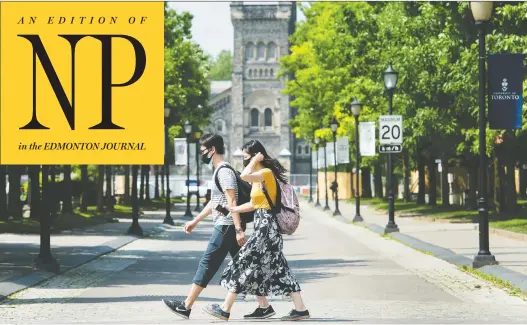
[0,224,172,302]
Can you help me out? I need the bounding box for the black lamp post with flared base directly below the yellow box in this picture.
[35,165,60,273]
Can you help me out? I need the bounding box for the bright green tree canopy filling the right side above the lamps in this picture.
[281,2,527,210]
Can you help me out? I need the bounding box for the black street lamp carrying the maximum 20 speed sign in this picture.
[382,64,399,234]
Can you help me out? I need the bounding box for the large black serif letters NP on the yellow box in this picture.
[17,34,146,130]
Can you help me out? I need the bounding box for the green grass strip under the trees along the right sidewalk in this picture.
[358,198,527,234]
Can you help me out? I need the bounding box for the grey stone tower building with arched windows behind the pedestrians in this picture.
[206,2,310,174]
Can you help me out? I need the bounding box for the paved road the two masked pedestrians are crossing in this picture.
[0,203,527,324]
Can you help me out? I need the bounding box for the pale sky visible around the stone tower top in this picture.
[169,1,305,56]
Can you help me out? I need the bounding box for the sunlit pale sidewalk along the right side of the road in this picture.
[329,197,527,292]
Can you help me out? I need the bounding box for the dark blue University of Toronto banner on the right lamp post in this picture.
[488,54,525,130]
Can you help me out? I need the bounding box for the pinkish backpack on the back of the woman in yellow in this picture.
[262,177,300,235]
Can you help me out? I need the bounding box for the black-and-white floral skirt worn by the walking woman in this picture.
[220,209,300,296]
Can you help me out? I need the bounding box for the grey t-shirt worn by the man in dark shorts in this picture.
[210,162,238,225]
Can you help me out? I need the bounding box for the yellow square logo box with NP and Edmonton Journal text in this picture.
[0,2,164,165]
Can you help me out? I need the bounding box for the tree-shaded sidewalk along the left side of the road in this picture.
[0,208,188,300]
